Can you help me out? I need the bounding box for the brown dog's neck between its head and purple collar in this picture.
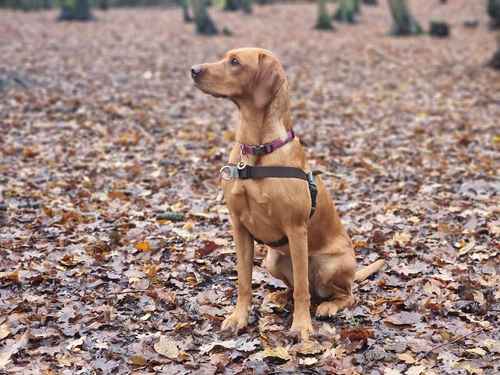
[236,84,292,145]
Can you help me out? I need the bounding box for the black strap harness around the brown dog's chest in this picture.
[220,163,320,247]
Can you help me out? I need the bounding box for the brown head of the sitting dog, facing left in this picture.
[191,48,286,109]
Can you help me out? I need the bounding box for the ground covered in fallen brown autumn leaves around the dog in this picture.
[0,0,500,375]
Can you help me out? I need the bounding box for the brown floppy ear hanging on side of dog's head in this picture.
[253,53,285,109]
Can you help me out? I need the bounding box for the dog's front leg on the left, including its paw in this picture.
[222,219,254,334]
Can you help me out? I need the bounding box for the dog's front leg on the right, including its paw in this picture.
[288,226,313,340]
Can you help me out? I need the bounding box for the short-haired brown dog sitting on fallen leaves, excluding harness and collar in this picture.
[191,48,383,340]
